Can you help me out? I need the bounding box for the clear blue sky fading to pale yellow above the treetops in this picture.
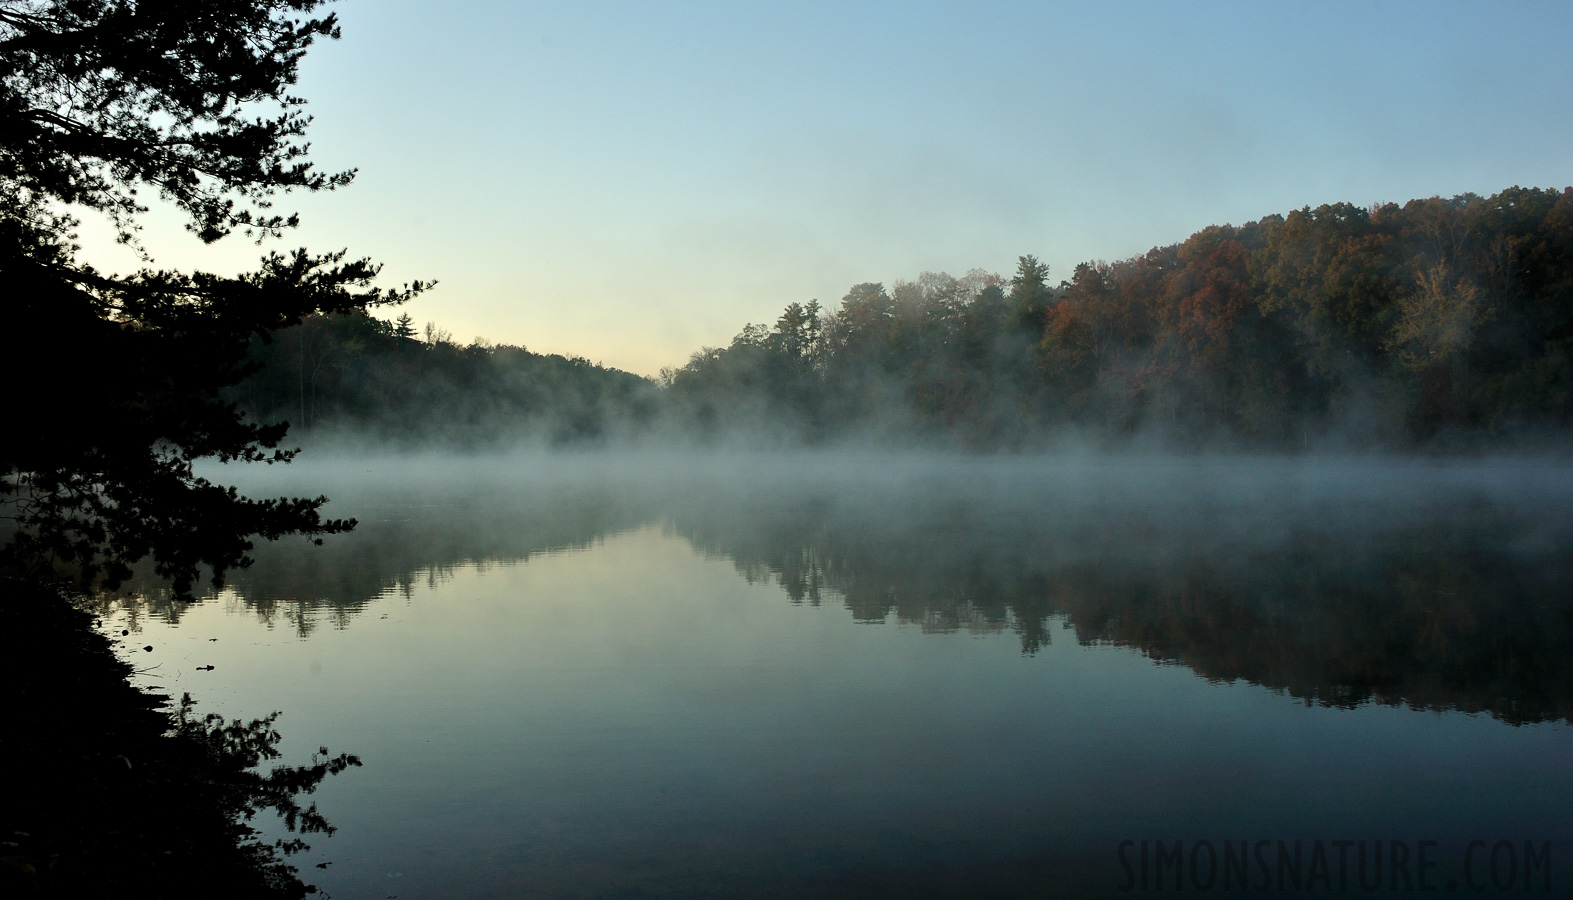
[70,0,1573,374]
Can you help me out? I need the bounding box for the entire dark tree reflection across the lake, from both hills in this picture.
[107,472,1573,724]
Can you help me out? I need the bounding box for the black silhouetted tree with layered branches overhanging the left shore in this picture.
[0,0,422,592]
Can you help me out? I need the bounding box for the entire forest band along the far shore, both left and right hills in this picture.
[239,187,1573,448]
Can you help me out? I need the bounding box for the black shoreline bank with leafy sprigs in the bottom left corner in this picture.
[0,579,347,898]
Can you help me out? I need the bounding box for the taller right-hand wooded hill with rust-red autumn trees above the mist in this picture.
[662,187,1573,448]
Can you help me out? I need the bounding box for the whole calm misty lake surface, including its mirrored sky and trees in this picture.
[110,456,1573,900]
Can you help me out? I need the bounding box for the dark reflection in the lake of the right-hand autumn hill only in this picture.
[673,490,1573,724]
